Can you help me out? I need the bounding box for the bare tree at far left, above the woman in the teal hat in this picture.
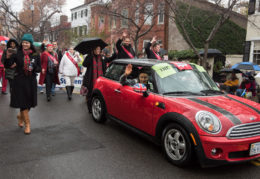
[0,0,65,40]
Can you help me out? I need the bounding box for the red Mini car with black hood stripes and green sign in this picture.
[92,59,260,167]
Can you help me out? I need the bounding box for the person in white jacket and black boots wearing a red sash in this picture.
[59,47,81,100]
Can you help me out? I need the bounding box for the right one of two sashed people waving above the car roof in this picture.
[145,36,162,60]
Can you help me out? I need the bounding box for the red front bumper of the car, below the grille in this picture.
[200,136,260,163]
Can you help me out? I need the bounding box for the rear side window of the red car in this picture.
[104,64,125,81]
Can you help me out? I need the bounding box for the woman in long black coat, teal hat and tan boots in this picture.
[5,34,41,134]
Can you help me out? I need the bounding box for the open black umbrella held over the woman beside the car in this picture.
[74,37,107,55]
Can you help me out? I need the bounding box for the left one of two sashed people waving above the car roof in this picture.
[116,32,135,59]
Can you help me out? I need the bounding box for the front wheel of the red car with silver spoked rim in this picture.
[162,123,192,167]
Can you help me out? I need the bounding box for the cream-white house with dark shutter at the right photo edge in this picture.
[243,0,260,64]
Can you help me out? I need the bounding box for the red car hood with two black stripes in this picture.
[166,95,260,135]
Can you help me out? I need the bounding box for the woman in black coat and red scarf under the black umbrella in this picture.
[82,46,116,113]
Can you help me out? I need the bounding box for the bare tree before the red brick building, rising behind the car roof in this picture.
[102,0,163,53]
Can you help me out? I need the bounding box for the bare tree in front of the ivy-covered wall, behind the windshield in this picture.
[165,0,241,68]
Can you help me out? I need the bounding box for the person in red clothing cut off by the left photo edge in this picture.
[0,41,7,94]
